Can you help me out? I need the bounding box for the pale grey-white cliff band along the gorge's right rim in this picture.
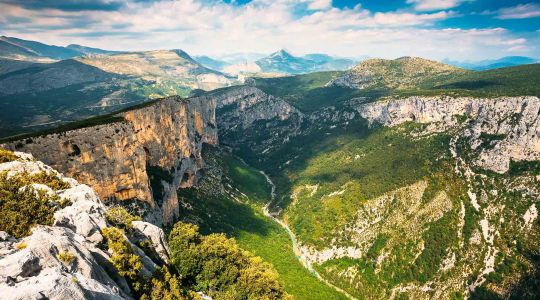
[358,96,540,173]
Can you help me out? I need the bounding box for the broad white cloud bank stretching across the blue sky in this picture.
[0,0,540,59]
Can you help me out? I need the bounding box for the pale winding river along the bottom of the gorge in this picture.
[259,171,357,300]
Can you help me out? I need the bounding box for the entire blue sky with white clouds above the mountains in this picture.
[0,0,540,60]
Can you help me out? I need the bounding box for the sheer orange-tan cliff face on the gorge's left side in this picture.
[4,97,218,224]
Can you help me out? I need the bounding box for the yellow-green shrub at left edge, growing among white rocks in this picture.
[0,171,69,238]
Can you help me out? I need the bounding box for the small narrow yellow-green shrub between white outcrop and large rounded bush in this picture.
[103,227,142,280]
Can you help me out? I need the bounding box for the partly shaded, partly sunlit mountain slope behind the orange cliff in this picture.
[0,50,234,137]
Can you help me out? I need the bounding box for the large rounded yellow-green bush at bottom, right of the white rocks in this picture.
[169,223,288,299]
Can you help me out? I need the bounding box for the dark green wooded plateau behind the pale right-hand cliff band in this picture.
[255,61,540,112]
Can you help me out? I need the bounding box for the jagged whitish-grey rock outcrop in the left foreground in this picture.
[0,153,167,300]
